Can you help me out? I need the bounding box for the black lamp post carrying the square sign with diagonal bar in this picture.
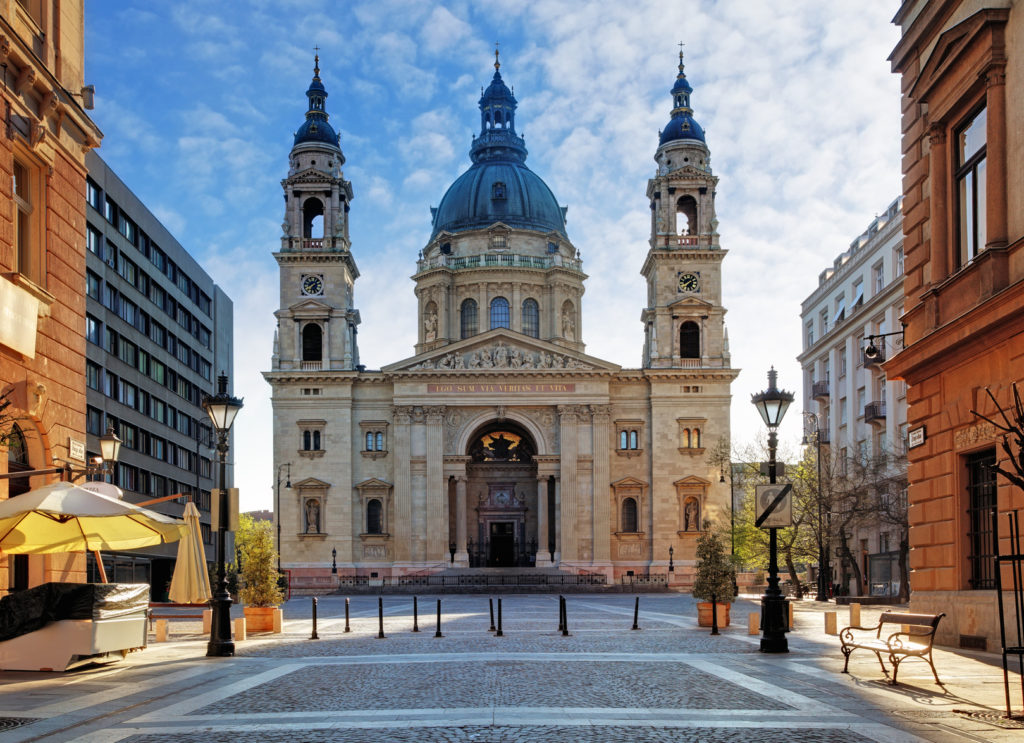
[751,366,793,653]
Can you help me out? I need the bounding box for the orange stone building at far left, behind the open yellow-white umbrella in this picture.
[0,0,102,596]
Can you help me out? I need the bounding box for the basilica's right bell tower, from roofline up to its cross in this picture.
[640,51,730,368]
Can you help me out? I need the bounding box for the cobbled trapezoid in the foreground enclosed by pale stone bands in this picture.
[196,661,786,714]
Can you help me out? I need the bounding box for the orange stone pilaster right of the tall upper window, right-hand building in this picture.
[979,64,1008,248]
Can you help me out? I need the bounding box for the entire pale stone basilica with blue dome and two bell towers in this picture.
[264,54,738,581]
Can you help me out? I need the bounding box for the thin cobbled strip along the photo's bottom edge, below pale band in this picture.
[124,726,873,743]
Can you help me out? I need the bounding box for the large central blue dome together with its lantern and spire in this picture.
[431,53,568,239]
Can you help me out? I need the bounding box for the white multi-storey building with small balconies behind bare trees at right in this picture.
[798,199,906,596]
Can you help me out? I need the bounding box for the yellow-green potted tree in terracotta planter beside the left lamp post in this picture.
[234,514,284,632]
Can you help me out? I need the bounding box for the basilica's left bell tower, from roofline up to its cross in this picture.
[272,55,359,372]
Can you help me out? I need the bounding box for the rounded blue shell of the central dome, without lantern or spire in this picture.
[431,160,567,238]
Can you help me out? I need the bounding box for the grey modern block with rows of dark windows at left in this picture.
[84,152,232,599]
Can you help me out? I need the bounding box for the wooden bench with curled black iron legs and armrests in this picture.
[839,611,945,686]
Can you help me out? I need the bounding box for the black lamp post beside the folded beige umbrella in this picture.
[203,374,242,657]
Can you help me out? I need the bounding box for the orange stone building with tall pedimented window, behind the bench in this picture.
[885,0,1024,649]
